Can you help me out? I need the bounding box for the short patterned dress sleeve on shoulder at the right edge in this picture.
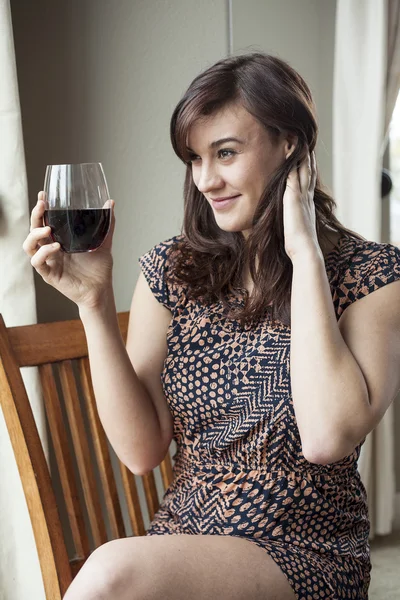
[355,244,400,300]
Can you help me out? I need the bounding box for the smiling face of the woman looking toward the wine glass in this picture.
[187,103,294,237]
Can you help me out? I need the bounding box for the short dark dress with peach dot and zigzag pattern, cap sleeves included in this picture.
[139,235,400,600]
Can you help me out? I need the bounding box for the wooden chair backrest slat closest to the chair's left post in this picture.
[39,365,90,558]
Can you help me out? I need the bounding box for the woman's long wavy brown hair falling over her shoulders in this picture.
[169,53,359,326]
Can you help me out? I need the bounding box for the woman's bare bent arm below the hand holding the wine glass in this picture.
[80,274,173,475]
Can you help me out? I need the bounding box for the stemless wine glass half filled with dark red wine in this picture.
[44,163,111,253]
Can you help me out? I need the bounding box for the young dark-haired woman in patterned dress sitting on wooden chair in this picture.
[24,53,400,600]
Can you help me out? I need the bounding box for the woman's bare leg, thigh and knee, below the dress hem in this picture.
[64,535,296,600]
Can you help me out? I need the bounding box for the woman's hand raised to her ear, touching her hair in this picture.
[283,152,321,261]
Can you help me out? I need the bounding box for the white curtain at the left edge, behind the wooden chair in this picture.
[0,0,45,600]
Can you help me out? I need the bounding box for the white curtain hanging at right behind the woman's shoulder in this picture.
[333,0,395,539]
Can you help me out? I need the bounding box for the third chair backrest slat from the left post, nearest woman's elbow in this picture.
[79,358,126,538]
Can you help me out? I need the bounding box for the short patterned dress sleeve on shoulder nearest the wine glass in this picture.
[138,236,182,311]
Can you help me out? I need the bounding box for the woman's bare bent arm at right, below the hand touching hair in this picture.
[290,251,400,464]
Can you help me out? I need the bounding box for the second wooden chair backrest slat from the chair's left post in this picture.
[58,360,107,547]
